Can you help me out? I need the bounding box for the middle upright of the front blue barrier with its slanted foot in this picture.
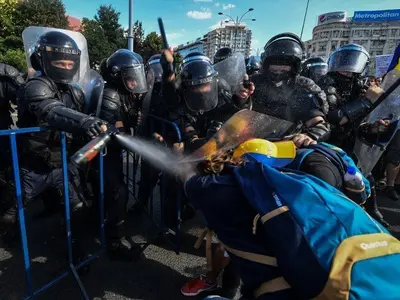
[61,132,90,300]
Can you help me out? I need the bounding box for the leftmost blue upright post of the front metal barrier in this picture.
[10,134,33,299]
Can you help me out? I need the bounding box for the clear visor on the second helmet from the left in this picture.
[121,64,148,94]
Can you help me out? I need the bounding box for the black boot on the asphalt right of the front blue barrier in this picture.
[107,222,142,261]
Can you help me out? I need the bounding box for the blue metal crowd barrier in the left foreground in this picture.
[0,127,104,299]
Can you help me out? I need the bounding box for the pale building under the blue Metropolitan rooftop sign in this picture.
[305,10,400,58]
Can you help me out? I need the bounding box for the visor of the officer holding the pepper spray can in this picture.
[38,46,81,84]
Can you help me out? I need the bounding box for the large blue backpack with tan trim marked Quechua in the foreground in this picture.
[234,162,400,300]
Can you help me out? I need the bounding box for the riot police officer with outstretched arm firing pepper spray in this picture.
[0,30,107,224]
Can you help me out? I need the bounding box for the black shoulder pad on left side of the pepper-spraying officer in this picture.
[24,77,57,101]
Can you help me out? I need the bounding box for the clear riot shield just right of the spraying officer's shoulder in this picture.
[80,70,104,117]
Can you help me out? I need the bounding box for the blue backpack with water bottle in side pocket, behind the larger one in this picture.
[287,143,371,204]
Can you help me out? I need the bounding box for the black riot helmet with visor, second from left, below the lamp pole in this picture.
[106,49,147,94]
